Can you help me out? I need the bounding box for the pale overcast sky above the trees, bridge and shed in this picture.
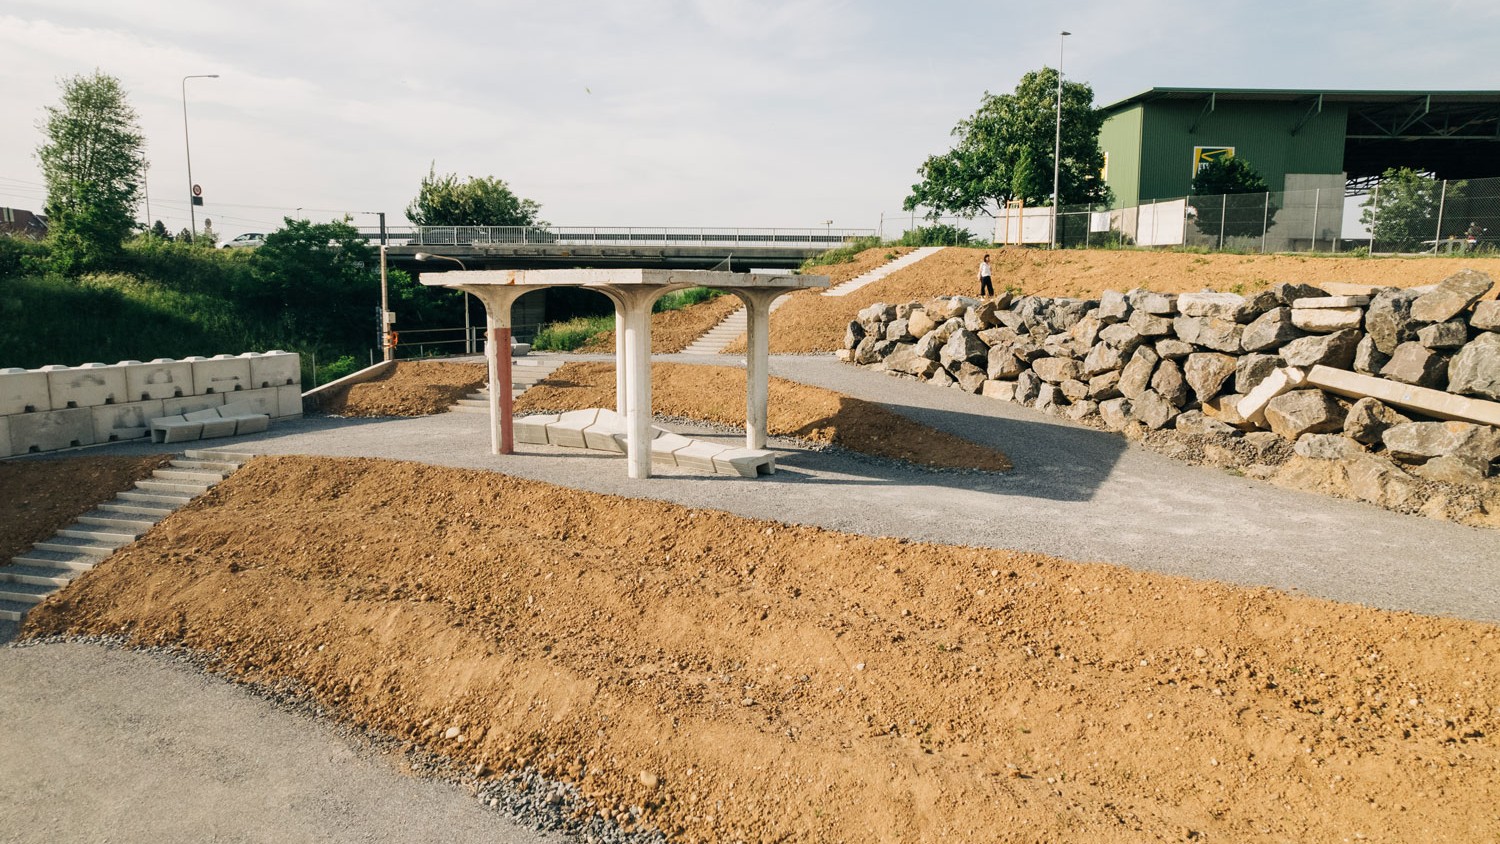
[0,0,1500,237]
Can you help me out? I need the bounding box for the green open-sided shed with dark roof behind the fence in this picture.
[1100,88,1500,207]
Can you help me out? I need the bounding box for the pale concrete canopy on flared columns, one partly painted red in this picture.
[419,270,828,478]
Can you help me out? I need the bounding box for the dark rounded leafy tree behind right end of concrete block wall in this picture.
[237,217,380,351]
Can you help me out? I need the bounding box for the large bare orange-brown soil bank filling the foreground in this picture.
[23,457,1500,843]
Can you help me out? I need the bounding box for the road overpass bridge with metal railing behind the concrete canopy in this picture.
[360,226,875,271]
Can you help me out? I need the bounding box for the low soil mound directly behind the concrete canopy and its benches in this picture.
[516,363,1011,472]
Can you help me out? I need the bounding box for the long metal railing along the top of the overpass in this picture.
[360,226,875,249]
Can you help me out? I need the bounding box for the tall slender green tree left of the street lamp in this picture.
[36,70,146,271]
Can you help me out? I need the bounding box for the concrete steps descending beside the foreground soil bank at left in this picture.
[0,450,252,622]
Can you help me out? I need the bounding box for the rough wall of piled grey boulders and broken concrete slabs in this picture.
[840,270,1500,483]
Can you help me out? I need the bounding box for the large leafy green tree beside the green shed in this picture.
[903,67,1110,217]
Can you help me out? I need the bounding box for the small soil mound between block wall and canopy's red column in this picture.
[323,360,489,417]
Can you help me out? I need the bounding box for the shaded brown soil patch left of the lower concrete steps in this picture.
[0,454,171,565]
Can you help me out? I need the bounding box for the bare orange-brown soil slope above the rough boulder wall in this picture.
[726,247,1500,354]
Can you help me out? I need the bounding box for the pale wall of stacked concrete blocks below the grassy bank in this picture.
[0,351,302,457]
